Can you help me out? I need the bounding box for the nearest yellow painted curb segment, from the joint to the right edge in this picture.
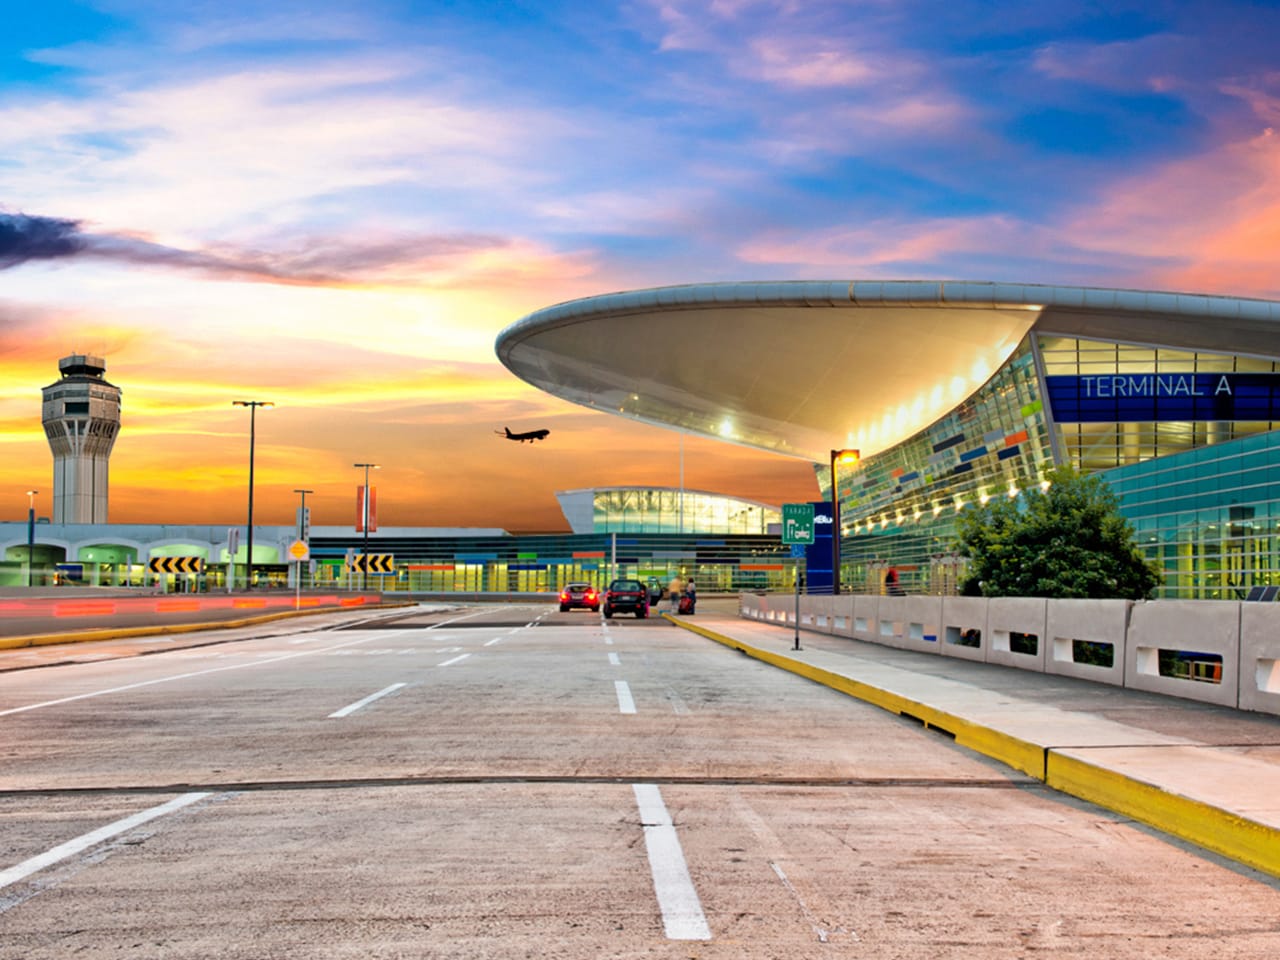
[1044,753,1280,877]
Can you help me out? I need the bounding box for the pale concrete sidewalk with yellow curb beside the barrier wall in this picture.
[663,603,1280,877]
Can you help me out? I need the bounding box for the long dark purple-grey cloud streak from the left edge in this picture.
[0,214,507,287]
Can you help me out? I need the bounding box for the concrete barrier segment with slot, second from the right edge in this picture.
[1125,600,1240,707]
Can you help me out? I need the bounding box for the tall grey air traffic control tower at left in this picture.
[41,353,120,524]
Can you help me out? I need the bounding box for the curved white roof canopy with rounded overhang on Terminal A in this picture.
[495,280,1280,462]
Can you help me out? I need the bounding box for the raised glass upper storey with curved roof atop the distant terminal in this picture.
[556,486,782,535]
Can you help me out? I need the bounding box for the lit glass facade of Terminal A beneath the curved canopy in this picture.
[815,337,1280,599]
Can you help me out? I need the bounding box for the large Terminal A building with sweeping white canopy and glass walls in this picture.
[495,280,1280,599]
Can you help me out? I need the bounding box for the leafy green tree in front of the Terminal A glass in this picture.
[956,467,1164,600]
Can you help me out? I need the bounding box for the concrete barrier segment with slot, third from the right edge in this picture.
[1044,599,1133,686]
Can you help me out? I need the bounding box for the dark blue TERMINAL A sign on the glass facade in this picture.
[1044,372,1280,424]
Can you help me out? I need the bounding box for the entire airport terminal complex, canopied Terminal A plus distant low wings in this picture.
[0,280,1280,599]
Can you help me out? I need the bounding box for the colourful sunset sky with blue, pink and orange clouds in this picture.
[0,0,1280,531]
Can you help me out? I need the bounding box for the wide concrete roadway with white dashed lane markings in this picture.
[0,602,1280,960]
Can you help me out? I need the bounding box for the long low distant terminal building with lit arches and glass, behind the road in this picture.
[0,496,791,598]
